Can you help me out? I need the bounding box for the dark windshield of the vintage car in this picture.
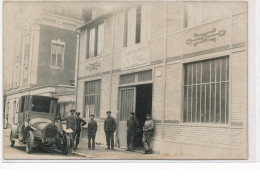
[32,96,54,114]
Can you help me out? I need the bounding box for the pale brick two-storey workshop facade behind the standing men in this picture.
[76,2,248,159]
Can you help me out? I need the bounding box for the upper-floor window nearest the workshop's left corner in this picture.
[87,23,104,58]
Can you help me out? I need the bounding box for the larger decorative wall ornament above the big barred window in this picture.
[185,28,227,47]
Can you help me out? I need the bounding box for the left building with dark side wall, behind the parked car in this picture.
[4,6,83,126]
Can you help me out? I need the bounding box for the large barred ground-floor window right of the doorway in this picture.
[183,56,229,124]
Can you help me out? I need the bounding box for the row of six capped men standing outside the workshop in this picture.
[61,110,154,154]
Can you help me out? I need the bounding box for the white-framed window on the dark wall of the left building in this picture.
[50,40,65,69]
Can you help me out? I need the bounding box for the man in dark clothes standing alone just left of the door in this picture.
[104,111,116,150]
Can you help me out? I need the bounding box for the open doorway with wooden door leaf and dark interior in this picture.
[118,84,153,147]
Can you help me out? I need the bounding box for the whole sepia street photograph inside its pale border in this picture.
[1,1,248,162]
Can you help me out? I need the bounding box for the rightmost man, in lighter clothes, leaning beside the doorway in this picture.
[142,114,154,154]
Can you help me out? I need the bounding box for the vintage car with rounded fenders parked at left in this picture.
[10,95,72,154]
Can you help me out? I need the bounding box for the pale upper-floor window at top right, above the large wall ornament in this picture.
[184,2,231,28]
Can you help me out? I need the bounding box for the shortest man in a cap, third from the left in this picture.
[88,115,97,150]
